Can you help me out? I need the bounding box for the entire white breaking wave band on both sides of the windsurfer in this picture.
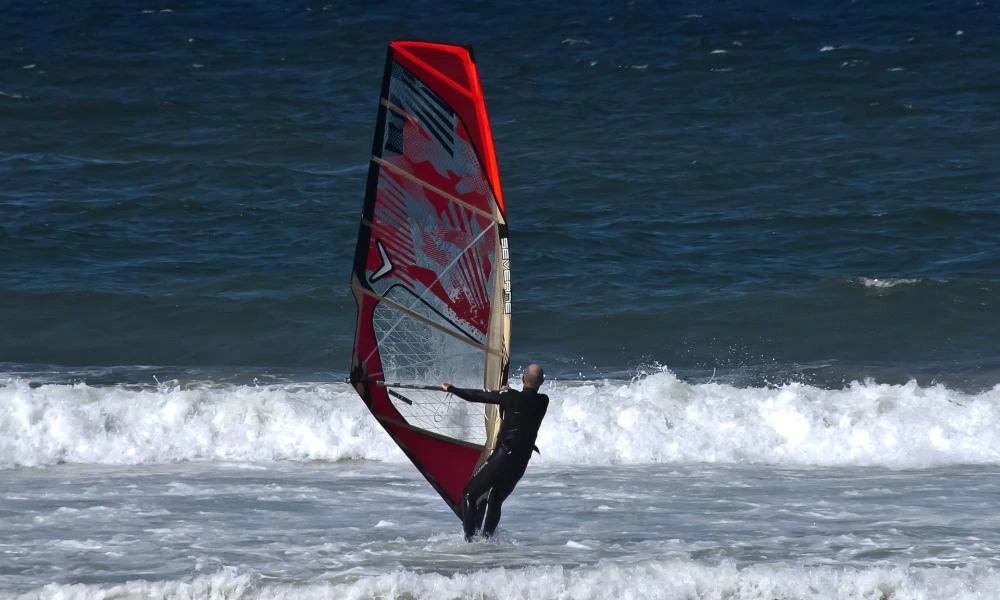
[0,370,1000,468]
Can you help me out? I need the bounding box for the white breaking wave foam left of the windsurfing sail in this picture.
[0,380,401,468]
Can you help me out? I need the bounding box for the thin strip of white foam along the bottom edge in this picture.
[7,559,1000,600]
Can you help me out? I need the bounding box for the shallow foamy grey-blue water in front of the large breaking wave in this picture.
[0,461,1000,599]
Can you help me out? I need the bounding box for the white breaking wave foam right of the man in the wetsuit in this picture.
[539,372,1000,468]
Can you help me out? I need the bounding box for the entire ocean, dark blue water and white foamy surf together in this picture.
[0,0,1000,600]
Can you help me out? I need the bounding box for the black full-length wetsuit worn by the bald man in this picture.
[448,386,549,540]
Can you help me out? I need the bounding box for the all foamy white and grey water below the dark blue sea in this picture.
[7,378,1000,599]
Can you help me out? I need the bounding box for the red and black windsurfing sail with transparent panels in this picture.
[350,41,510,516]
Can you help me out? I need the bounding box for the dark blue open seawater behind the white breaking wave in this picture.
[0,0,1000,390]
